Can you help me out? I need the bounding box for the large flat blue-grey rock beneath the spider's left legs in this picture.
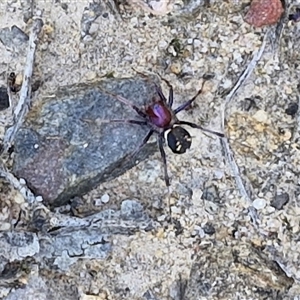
[13,77,157,206]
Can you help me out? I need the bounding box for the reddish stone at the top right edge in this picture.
[244,0,284,27]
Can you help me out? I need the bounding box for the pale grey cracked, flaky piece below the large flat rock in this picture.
[0,200,156,274]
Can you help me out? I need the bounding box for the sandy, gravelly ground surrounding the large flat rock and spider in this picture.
[0,0,300,300]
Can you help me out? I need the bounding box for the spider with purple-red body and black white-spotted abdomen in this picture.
[102,75,224,187]
